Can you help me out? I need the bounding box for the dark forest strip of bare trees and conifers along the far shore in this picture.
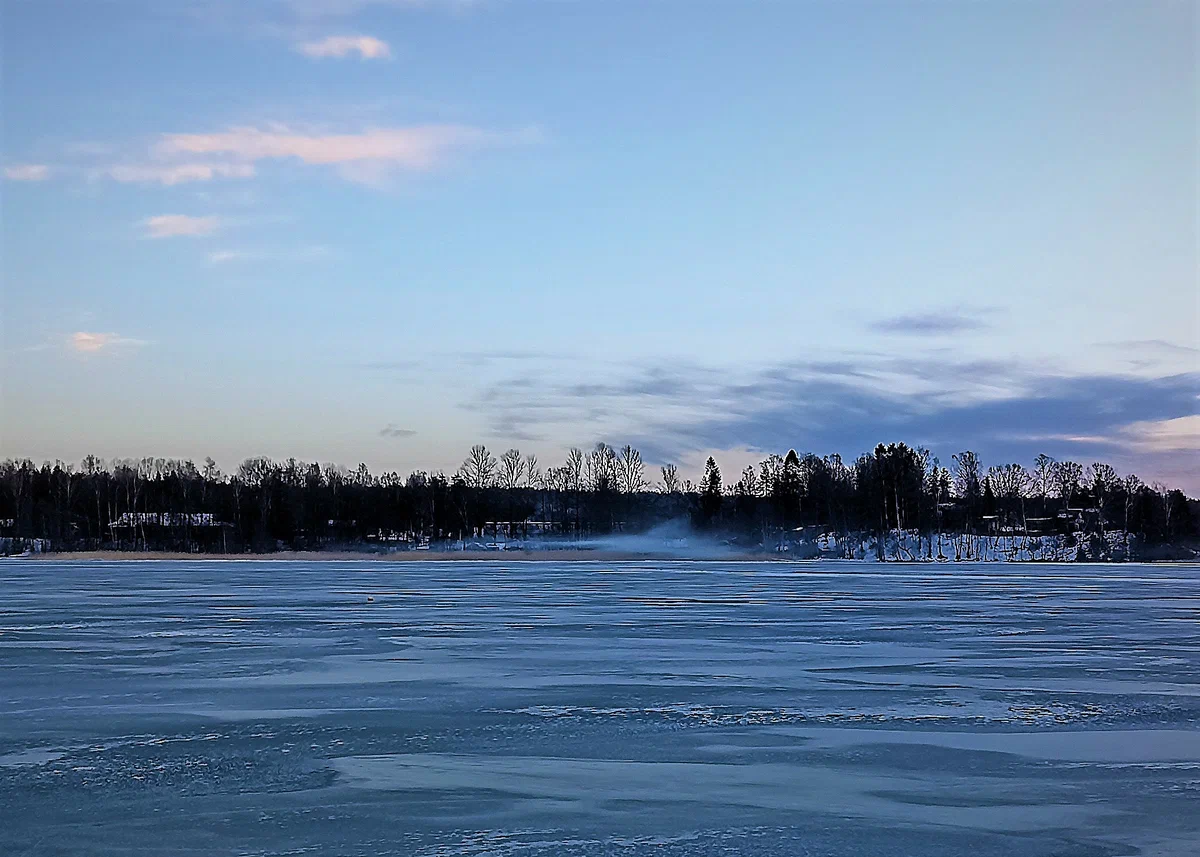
[0,443,1200,557]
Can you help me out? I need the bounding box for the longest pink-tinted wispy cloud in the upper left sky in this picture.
[155,125,539,180]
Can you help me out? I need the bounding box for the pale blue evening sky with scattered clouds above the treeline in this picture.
[0,0,1200,495]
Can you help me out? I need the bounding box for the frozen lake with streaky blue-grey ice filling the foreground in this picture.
[0,561,1200,857]
